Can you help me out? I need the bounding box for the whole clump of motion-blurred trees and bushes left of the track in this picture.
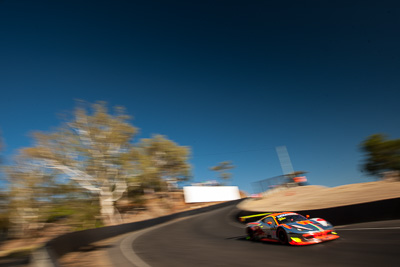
[0,102,191,241]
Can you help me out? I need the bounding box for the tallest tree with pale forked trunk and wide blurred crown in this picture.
[22,102,137,224]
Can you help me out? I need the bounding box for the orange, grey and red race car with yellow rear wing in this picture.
[241,212,339,245]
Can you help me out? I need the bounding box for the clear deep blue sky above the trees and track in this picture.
[0,0,400,192]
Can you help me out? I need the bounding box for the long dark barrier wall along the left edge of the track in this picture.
[31,199,241,267]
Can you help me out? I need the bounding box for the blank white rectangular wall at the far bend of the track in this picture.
[183,186,240,203]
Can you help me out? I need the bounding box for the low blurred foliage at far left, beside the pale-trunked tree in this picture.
[5,155,99,238]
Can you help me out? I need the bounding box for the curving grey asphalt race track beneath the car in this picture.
[109,206,400,267]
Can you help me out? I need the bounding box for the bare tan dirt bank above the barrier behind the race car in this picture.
[238,181,400,211]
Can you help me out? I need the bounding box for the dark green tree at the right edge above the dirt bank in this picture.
[361,134,400,180]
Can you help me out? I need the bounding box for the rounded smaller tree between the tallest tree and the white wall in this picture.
[137,135,191,193]
